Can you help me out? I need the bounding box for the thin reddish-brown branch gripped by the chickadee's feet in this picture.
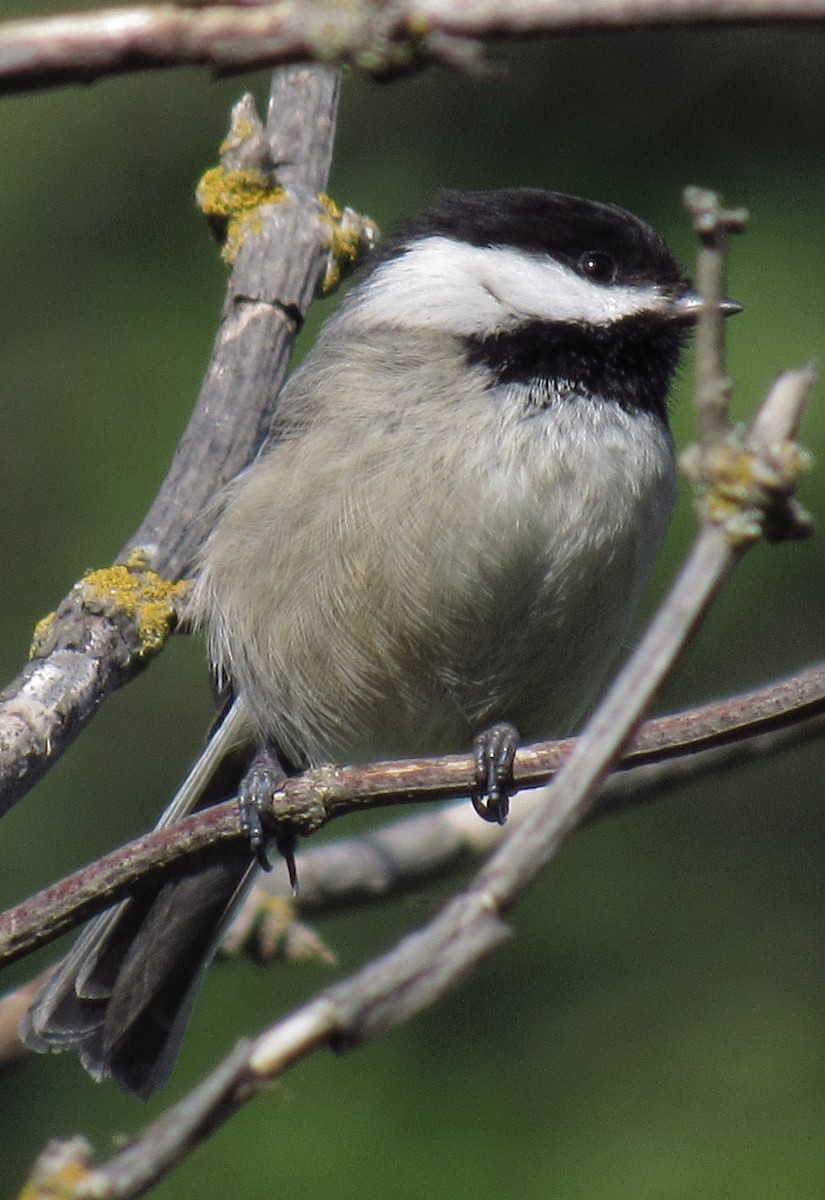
[0,664,825,966]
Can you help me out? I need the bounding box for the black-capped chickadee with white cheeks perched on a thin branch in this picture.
[23,190,739,1096]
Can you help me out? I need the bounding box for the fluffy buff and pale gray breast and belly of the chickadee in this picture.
[198,328,673,762]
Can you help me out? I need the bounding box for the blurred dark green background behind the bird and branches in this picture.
[0,7,825,1200]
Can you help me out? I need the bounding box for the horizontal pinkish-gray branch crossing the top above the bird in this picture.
[0,0,825,92]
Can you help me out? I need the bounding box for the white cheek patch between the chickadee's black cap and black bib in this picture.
[350,238,668,337]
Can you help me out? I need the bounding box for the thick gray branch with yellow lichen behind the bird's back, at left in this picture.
[0,66,354,815]
